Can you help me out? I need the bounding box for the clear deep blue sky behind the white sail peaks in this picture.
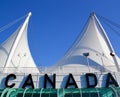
[0,0,120,66]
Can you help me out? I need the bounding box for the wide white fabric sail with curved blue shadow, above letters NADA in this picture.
[49,14,119,73]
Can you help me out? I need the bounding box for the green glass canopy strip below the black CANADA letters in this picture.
[0,87,120,97]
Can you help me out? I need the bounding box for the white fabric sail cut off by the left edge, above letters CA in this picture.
[0,13,39,73]
